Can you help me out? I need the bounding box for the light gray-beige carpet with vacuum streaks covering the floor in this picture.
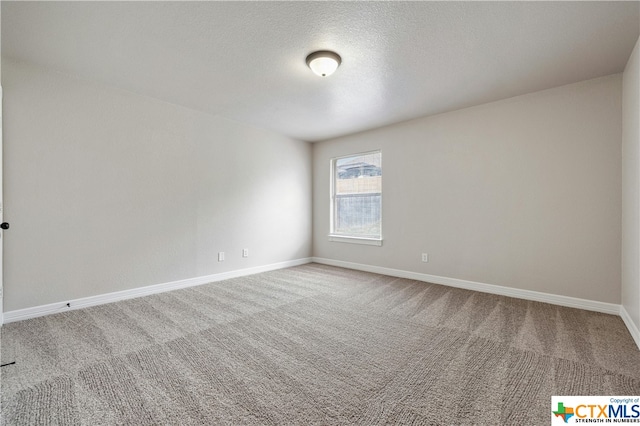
[1,264,640,425]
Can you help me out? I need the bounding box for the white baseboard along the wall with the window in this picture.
[312,257,620,315]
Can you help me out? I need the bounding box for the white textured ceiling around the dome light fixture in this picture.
[2,1,640,141]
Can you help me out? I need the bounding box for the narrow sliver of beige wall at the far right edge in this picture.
[622,39,640,329]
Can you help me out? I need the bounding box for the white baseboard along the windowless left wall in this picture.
[3,257,311,324]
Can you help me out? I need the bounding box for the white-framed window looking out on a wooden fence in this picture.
[329,151,382,246]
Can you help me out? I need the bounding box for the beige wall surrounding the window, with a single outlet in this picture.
[313,74,622,303]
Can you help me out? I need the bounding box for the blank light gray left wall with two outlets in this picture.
[2,58,312,312]
